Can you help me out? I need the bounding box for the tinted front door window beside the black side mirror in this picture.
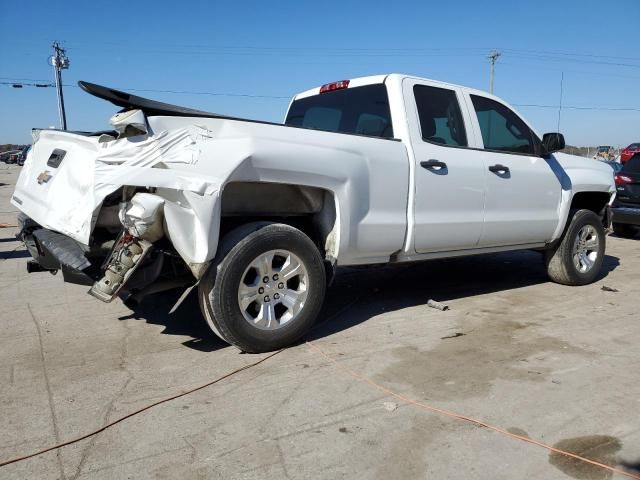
[471,95,540,155]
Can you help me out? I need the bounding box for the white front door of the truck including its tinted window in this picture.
[467,94,562,247]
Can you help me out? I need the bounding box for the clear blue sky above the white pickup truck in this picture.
[0,0,640,146]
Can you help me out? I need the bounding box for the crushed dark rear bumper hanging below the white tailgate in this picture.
[16,214,98,285]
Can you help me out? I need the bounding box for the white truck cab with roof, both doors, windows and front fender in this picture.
[285,74,613,260]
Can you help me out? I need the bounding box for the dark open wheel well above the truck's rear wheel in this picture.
[220,182,338,263]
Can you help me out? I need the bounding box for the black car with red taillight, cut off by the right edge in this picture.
[611,153,640,237]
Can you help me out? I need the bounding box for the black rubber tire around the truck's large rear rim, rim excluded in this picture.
[198,222,326,353]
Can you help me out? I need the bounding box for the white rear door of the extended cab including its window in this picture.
[403,78,485,253]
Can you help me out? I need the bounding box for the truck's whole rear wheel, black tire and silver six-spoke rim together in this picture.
[199,222,326,353]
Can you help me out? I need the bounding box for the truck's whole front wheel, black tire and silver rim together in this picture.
[547,210,606,285]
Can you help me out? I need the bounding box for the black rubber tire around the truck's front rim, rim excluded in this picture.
[546,210,606,286]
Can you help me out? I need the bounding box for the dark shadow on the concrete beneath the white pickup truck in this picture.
[120,251,620,352]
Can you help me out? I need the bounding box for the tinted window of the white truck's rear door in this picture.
[413,85,467,147]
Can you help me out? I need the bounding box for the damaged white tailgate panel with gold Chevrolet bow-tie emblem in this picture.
[11,130,99,244]
